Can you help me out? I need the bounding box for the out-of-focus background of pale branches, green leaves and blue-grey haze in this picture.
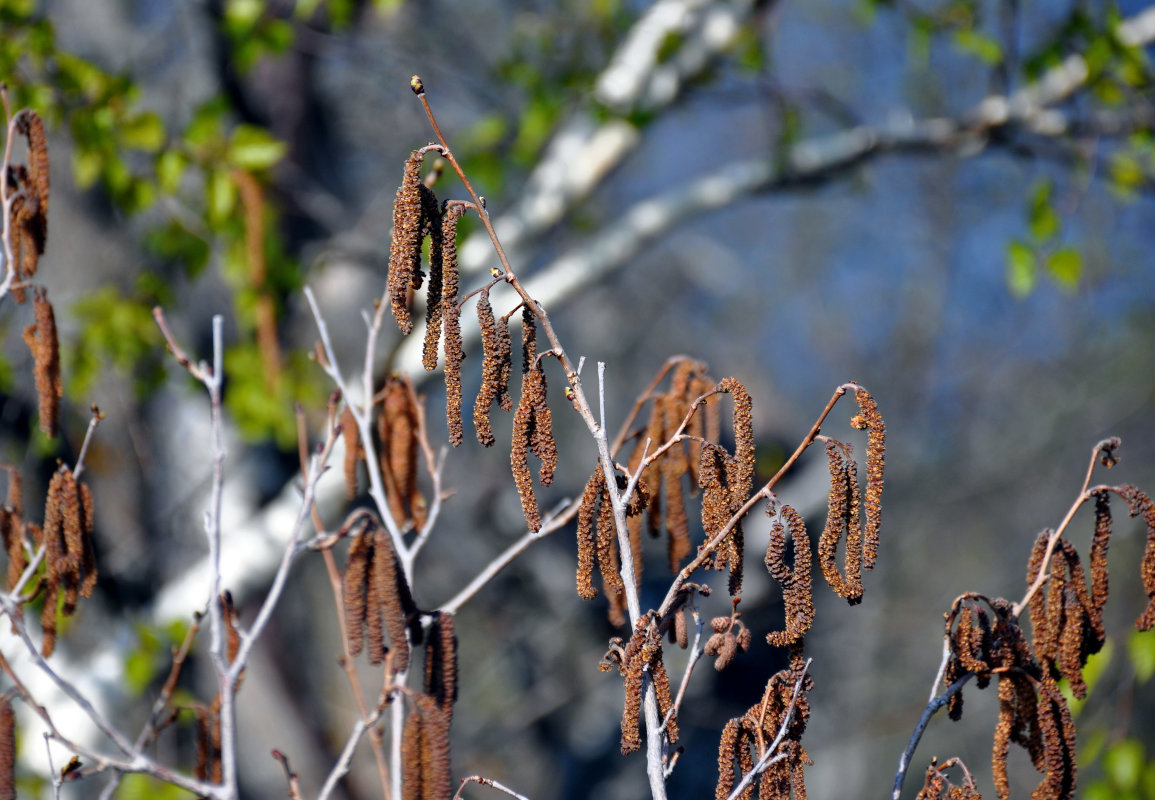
[0,0,1155,800]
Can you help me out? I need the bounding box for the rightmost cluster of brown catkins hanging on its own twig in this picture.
[942,439,1155,800]
